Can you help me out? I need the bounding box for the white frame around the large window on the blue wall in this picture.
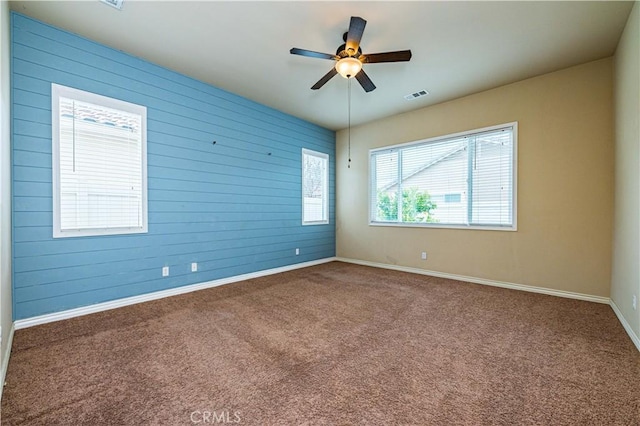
[51,83,149,238]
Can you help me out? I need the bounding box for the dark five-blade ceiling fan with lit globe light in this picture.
[289,16,411,92]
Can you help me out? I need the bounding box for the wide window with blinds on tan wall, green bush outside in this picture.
[370,123,517,230]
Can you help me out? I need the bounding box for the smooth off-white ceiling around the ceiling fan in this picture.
[10,0,633,130]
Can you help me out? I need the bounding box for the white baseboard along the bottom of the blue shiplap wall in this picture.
[14,257,336,330]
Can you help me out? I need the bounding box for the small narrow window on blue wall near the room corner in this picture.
[302,149,329,225]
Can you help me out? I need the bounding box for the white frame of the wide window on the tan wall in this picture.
[367,121,518,232]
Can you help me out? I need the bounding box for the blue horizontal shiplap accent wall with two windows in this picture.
[11,14,335,319]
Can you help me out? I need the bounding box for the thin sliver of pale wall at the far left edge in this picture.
[0,1,12,396]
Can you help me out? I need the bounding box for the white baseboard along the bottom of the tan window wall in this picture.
[336,257,609,305]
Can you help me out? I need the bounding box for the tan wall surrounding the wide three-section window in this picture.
[336,58,614,297]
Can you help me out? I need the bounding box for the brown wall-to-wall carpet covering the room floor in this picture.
[2,262,640,425]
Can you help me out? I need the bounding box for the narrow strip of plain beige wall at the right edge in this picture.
[611,2,640,336]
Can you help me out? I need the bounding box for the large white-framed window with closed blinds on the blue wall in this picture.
[51,84,147,238]
